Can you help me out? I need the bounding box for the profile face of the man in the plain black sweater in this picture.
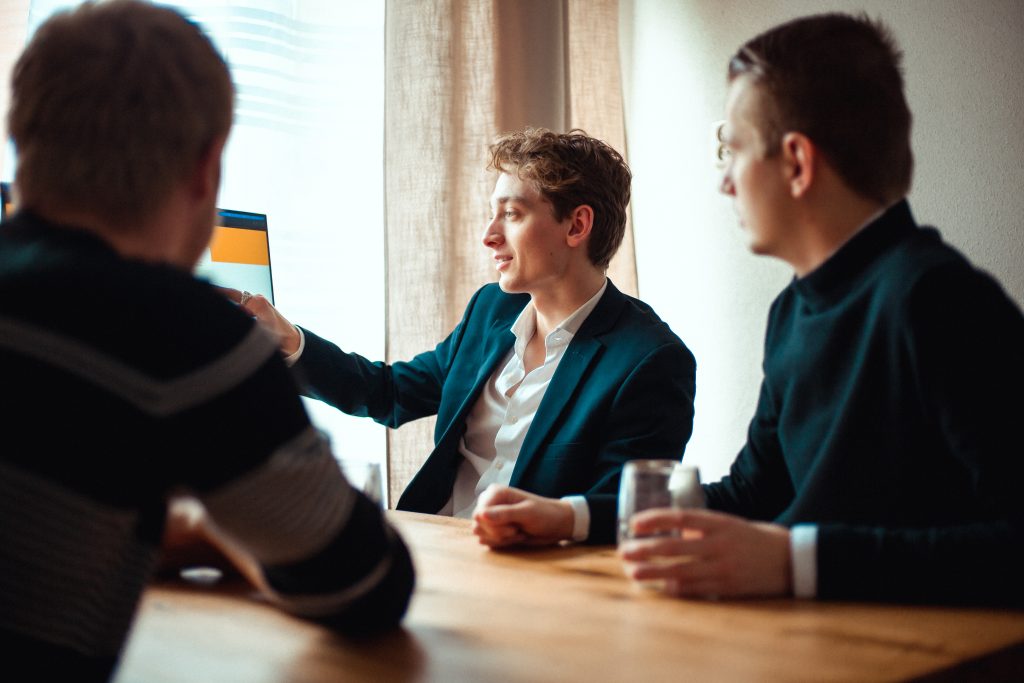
[720,77,792,256]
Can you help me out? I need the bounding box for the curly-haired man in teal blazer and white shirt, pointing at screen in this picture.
[237,129,695,545]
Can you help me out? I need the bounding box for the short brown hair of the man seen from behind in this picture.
[7,0,234,226]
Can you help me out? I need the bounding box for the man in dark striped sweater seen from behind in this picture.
[0,0,413,681]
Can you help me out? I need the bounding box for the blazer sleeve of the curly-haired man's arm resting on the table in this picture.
[584,341,696,544]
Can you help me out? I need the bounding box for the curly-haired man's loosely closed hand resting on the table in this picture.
[473,484,575,548]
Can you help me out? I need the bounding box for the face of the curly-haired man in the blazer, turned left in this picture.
[483,173,571,295]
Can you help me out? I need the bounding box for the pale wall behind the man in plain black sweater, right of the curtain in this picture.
[622,0,1024,481]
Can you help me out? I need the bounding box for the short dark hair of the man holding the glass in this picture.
[729,13,913,205]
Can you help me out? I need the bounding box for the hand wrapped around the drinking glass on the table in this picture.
[618,508,793,598]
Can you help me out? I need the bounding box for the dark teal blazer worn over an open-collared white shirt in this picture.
[296,282,696,543]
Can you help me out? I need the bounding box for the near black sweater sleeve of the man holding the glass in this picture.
[817,264,1024,605]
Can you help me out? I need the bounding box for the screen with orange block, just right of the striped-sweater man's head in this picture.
[196,209,273,303]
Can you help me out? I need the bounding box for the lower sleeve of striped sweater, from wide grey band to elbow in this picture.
[201,427,414,632]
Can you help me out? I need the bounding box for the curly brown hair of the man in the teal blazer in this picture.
[487,128,633,268]
